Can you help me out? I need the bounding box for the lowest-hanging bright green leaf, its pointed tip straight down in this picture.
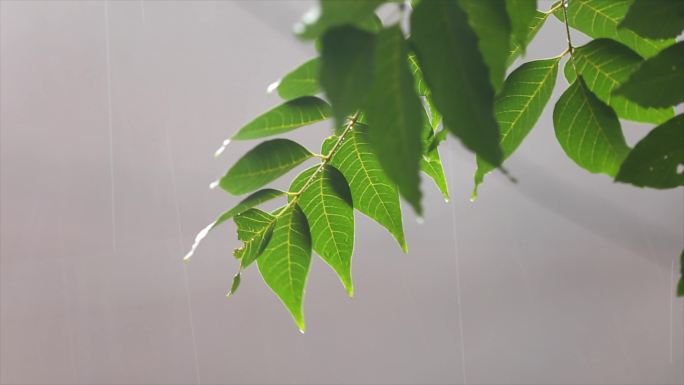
[257,205,311,333]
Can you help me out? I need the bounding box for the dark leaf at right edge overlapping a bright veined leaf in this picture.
[615,42,684,107]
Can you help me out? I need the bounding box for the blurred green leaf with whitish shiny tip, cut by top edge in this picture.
[295,0,384,39]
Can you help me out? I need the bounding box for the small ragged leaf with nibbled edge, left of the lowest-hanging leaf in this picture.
[233,209,276,270]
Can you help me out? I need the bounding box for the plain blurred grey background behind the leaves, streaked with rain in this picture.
[0,0,684,384]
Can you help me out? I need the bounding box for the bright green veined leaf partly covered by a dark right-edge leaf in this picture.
[565,39,674,123]
